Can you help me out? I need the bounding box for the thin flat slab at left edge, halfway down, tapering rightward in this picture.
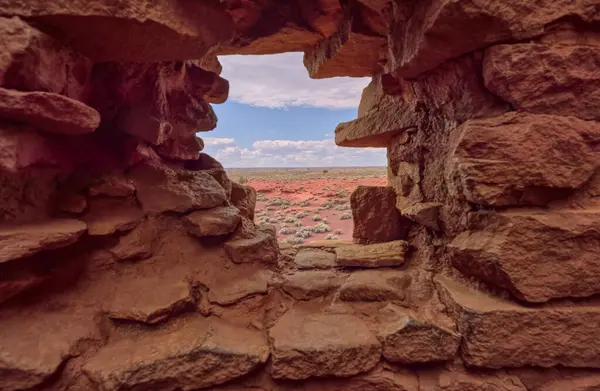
[0,219,87,263]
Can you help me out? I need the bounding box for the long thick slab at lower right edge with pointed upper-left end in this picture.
[435,276,600,368]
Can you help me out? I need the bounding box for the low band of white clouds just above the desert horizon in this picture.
[204,139,386,168]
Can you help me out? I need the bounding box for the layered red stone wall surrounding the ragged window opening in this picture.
[0,0,600,391]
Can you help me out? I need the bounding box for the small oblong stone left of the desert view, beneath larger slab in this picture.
[185,206,241,237]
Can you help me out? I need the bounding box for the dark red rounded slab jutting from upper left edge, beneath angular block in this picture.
[0,88,100,134]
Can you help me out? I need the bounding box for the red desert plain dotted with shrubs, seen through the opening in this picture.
[228,167,387,244]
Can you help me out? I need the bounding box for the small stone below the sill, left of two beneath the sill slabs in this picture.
[281,270,343,300]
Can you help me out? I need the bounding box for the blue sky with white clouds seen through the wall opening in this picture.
[198,53,385,168]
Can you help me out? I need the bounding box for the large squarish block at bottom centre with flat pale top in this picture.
[269,308,381,380]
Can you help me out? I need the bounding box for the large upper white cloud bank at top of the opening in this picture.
[219,53,370,109]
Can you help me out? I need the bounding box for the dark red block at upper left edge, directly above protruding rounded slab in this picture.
[0,16,92,100]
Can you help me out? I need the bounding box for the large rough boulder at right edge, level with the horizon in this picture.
[446,112,600,206]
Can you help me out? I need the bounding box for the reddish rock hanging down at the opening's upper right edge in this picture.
[304,14,386,79]
